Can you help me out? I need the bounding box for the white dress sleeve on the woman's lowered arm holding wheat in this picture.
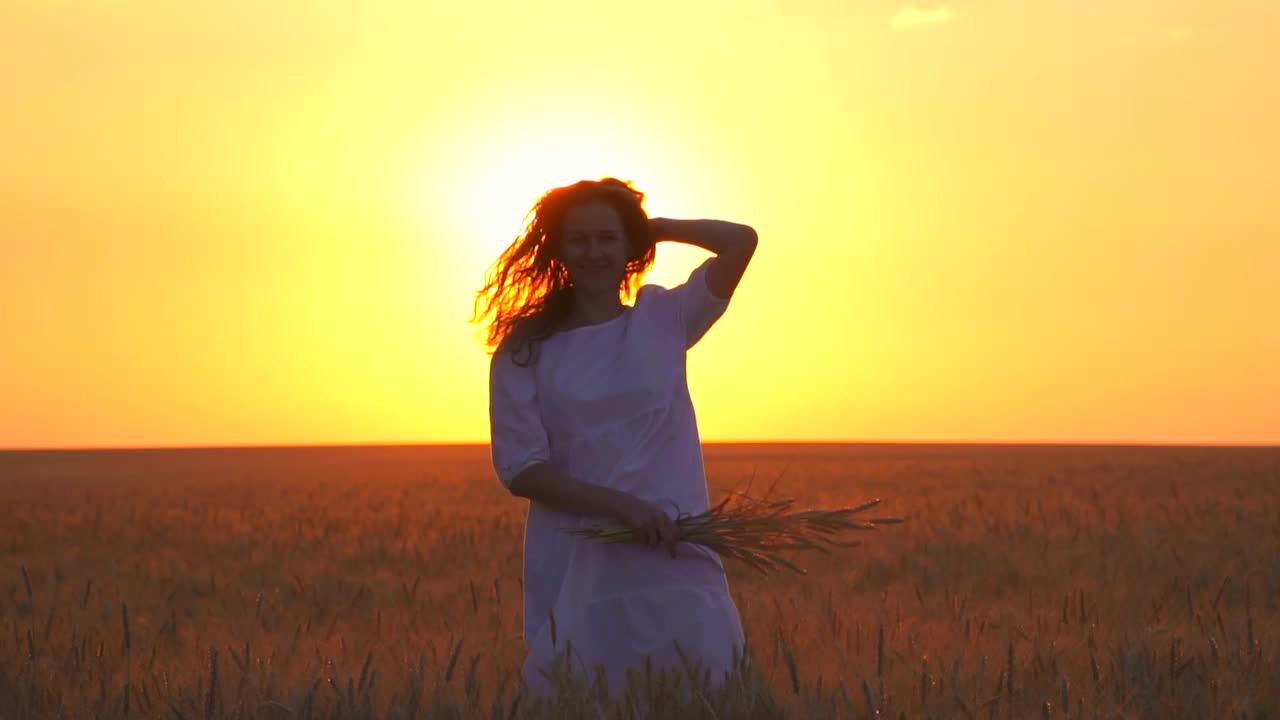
[489,351,550,489]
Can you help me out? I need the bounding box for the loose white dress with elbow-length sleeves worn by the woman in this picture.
[489,259,744,693]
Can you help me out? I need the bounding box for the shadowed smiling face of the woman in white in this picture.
[561,202,627,291]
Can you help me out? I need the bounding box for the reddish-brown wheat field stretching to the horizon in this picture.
[0,445,1280,720]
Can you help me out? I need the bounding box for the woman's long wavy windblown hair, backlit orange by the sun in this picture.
[471,177,654,366]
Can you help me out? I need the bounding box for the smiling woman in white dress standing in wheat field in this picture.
[476,178,756,694]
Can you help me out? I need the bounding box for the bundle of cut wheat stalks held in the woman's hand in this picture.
[566,492,902,574]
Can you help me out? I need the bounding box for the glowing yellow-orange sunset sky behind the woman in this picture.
[0,0,1280,448]
